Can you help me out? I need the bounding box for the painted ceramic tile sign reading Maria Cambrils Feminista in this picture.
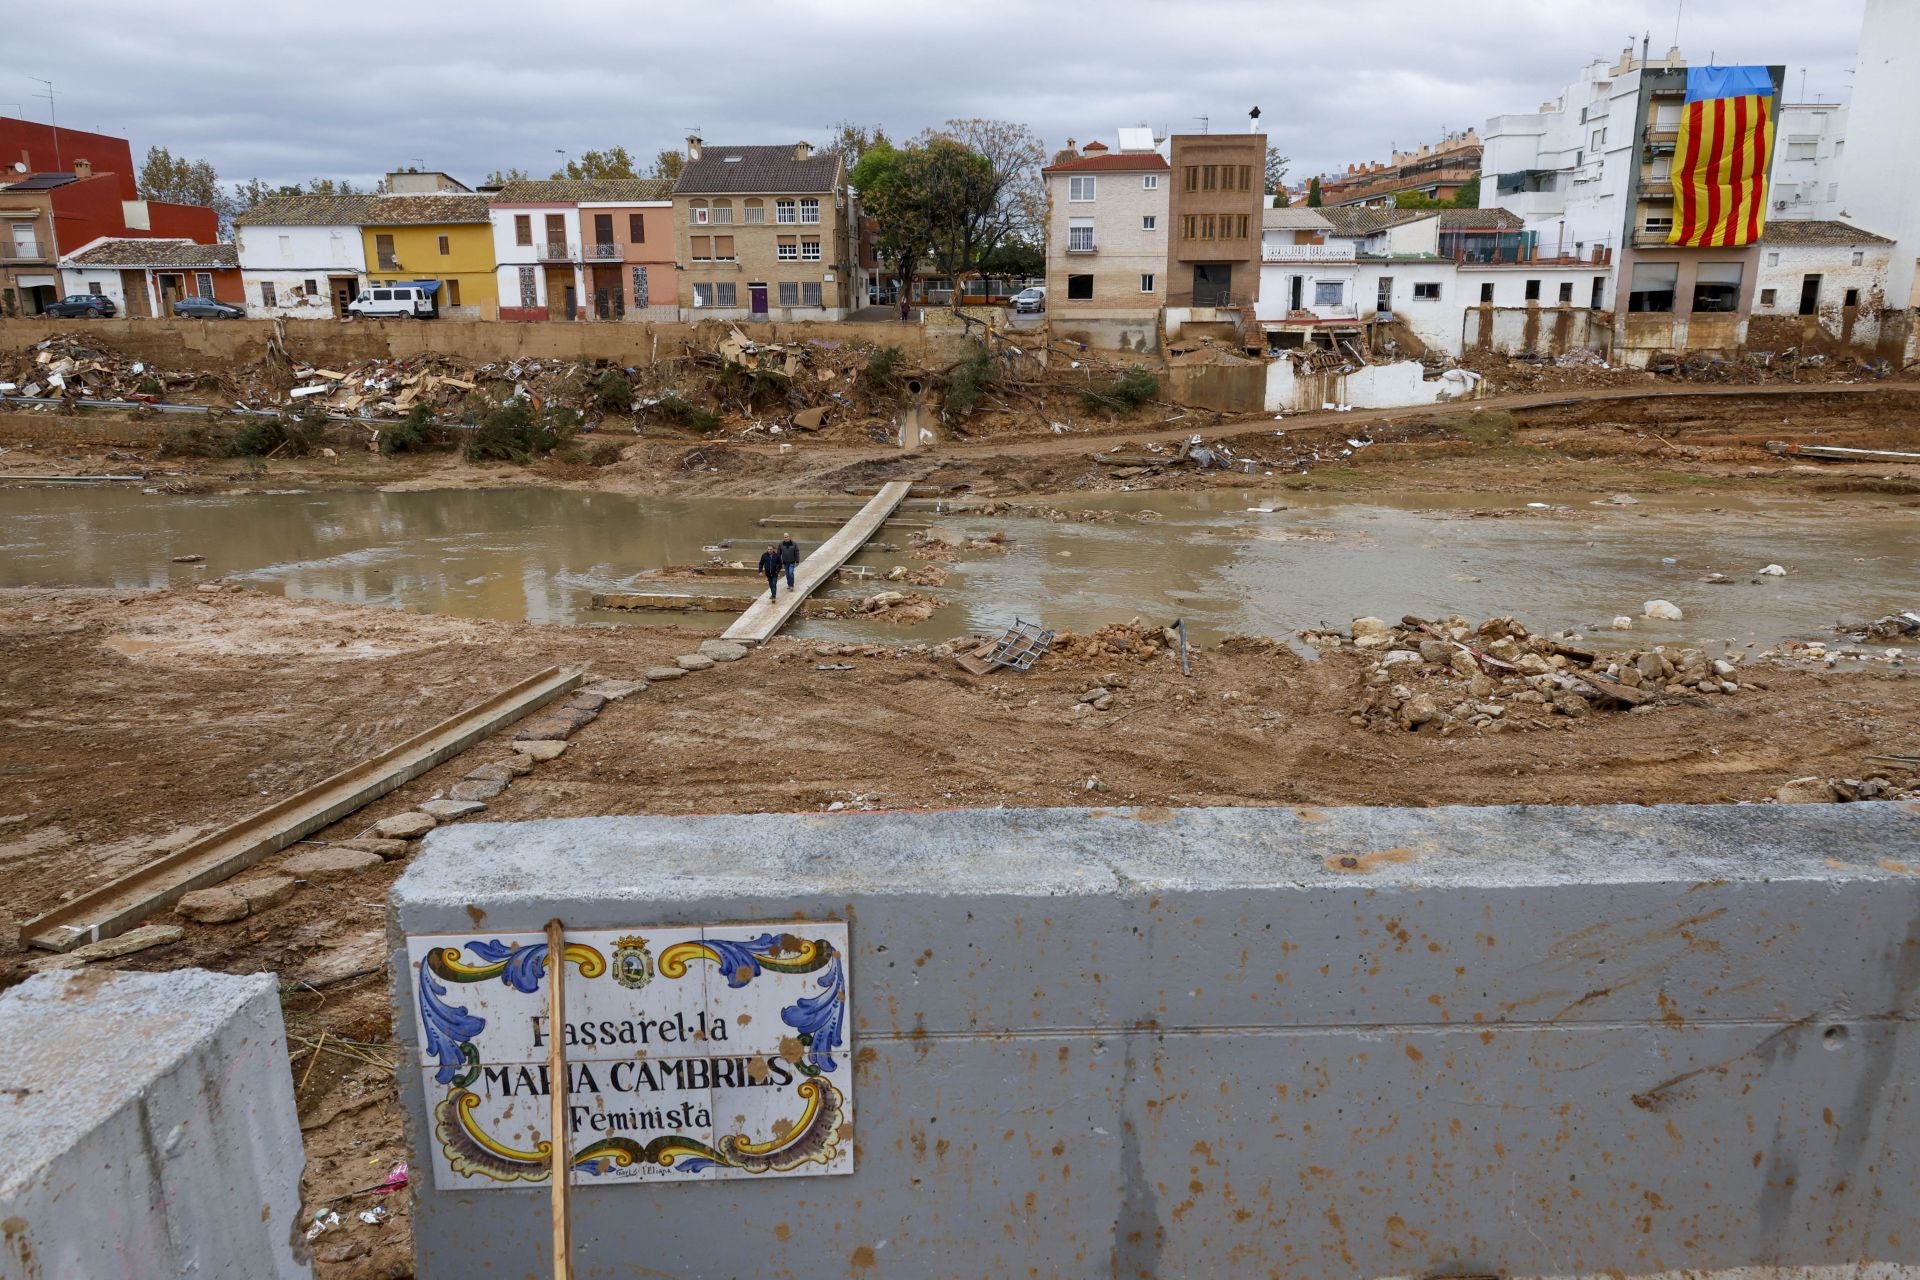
[407,921,852,1190]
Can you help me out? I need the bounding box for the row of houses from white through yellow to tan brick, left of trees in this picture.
[234,138,860,320]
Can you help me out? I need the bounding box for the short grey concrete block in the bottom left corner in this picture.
[0,969,313,1280]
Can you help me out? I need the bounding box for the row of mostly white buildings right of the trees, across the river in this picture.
[1044,0,1920,365]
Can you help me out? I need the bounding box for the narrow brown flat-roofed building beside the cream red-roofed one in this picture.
[1165,132,1267,340]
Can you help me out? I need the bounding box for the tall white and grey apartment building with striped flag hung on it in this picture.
[1480,48,1784,365]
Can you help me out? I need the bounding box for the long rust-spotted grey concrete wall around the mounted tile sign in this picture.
[390,804,1920,1280]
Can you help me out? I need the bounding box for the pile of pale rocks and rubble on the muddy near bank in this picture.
[1302,616,1740,735]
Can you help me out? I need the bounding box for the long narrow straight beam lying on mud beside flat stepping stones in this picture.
[19,666,584,952]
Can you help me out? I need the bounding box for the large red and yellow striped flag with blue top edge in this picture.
[1667,67,1774,248]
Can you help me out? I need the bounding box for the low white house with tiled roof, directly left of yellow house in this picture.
[234,196,380,320]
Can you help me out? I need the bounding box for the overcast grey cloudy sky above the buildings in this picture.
[0,0,1858,184]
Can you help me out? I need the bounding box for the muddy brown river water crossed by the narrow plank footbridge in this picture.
[0,489,1920,645]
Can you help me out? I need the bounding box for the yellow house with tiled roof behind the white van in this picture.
[361,194,499,320]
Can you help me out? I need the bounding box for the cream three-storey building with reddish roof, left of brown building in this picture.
[1041,129,1169,349]
